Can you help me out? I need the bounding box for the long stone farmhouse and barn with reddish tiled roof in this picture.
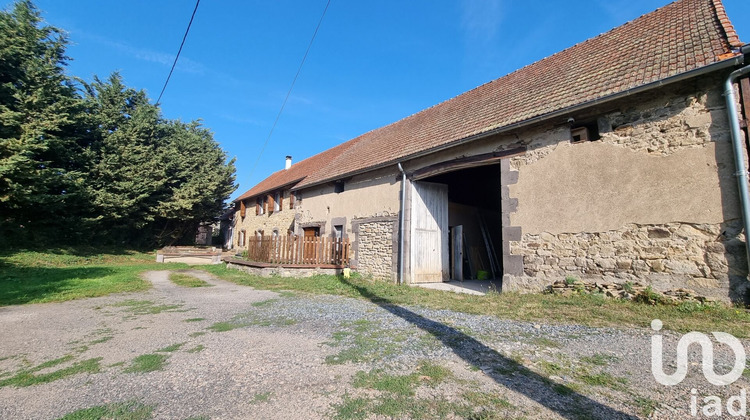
[232,0,750,300]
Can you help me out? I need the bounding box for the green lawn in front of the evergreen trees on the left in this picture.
[0,249,186,306]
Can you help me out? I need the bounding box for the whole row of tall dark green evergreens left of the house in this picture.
[0,0,236,246]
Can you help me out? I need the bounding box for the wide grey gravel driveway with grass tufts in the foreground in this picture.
[0,271,748,419]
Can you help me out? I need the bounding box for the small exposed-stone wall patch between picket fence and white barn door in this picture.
[352,217,398,280]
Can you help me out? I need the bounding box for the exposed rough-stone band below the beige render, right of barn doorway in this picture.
[509,221,748,301]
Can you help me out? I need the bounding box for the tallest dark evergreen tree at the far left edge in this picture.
[0,1,87,241]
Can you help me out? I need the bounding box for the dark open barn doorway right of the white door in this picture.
[415,164,503,281]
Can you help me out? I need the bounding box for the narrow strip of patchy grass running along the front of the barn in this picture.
[201,264,750,337]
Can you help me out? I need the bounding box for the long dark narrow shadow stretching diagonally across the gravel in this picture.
[339,277,637,419]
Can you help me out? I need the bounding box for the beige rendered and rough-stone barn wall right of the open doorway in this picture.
[504,73,748,301]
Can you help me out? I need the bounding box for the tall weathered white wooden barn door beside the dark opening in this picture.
[411,182,449,283]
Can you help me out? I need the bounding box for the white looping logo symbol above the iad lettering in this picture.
[651,319,746,386]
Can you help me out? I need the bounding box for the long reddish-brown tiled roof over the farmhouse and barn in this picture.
[238,0,742,200]
